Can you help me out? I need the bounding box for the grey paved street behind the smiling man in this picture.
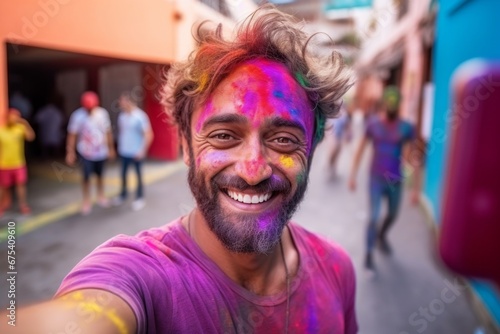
[0,121,479,334]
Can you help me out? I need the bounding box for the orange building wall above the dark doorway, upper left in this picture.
[0,0,177,121]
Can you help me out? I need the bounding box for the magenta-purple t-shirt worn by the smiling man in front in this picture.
[56,219,357,334]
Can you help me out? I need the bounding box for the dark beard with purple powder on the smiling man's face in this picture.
[188,149,308,254]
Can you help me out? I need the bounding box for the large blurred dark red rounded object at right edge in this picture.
[439,60,500,286]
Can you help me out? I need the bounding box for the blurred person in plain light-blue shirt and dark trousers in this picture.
[113,92,153,211]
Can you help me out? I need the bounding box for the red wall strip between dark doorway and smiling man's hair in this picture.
[143,65,179,160]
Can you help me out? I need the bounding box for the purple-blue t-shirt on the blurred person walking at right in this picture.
[366,117,415,180]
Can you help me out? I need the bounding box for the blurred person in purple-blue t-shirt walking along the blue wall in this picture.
[349,86,419,270]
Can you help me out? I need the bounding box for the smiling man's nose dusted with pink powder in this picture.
[235,143,273,186]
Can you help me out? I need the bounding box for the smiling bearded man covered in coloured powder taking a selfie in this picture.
[0,6,357,334]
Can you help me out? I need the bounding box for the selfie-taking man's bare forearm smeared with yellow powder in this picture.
[0,289,137,334]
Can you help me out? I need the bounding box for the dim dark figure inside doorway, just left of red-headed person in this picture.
[33,95,64,159]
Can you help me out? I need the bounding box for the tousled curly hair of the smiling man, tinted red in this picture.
[161,5,353,145]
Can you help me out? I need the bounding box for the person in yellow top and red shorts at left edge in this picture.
[0,108,35,216]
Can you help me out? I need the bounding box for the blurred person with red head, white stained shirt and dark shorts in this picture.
[66,91,116,215]
